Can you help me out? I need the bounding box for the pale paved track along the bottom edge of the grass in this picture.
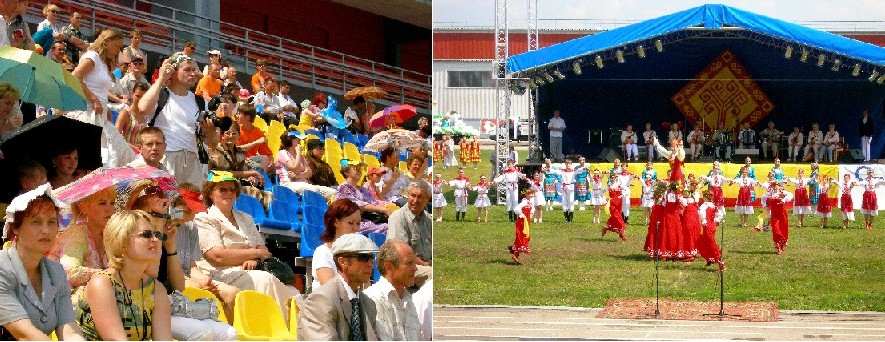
[433,306,885,341]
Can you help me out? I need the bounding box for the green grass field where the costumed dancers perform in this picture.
[434,151,885,311]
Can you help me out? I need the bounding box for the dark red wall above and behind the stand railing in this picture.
[221,0,431,74]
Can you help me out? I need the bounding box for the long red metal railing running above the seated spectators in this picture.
[33,0,431,113]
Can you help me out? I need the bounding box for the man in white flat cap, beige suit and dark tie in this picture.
[298,233,378,341]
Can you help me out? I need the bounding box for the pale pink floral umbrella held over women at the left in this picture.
[53,166,178,204]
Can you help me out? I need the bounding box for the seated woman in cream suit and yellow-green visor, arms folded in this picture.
[194,174,298,318]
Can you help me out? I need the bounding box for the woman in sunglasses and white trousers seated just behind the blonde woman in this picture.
[118,180,237,341]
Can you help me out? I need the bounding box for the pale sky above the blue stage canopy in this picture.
[433,0,885,31]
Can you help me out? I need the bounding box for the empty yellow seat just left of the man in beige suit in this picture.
[234,290,297,341]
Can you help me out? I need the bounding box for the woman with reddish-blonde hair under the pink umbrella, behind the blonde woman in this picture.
[49,187,117,289]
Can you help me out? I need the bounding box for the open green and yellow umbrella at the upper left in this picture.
[0,46,86,110]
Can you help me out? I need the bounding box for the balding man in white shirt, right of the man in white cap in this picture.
[363,239,422,341]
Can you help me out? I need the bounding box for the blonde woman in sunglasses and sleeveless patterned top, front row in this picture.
[74,210,172,341]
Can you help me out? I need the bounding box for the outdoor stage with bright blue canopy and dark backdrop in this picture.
[506,5,885,159]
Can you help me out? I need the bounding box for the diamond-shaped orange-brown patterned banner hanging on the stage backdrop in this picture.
[672,50,774,132]
